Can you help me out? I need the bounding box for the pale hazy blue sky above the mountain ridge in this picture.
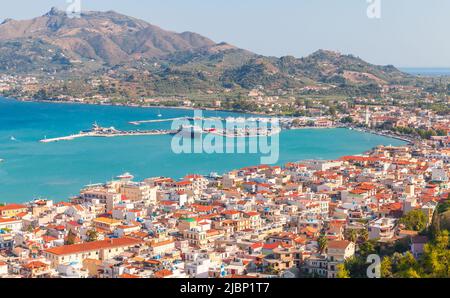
[0,0,450,67]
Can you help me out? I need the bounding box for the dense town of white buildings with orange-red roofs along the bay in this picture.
[0,116,450,278]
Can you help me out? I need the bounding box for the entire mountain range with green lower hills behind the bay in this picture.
[0,8,411,96]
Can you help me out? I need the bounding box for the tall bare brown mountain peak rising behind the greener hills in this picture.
[0,8,215,65]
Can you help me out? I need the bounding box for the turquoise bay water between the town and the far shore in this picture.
[0,98,402,202]
